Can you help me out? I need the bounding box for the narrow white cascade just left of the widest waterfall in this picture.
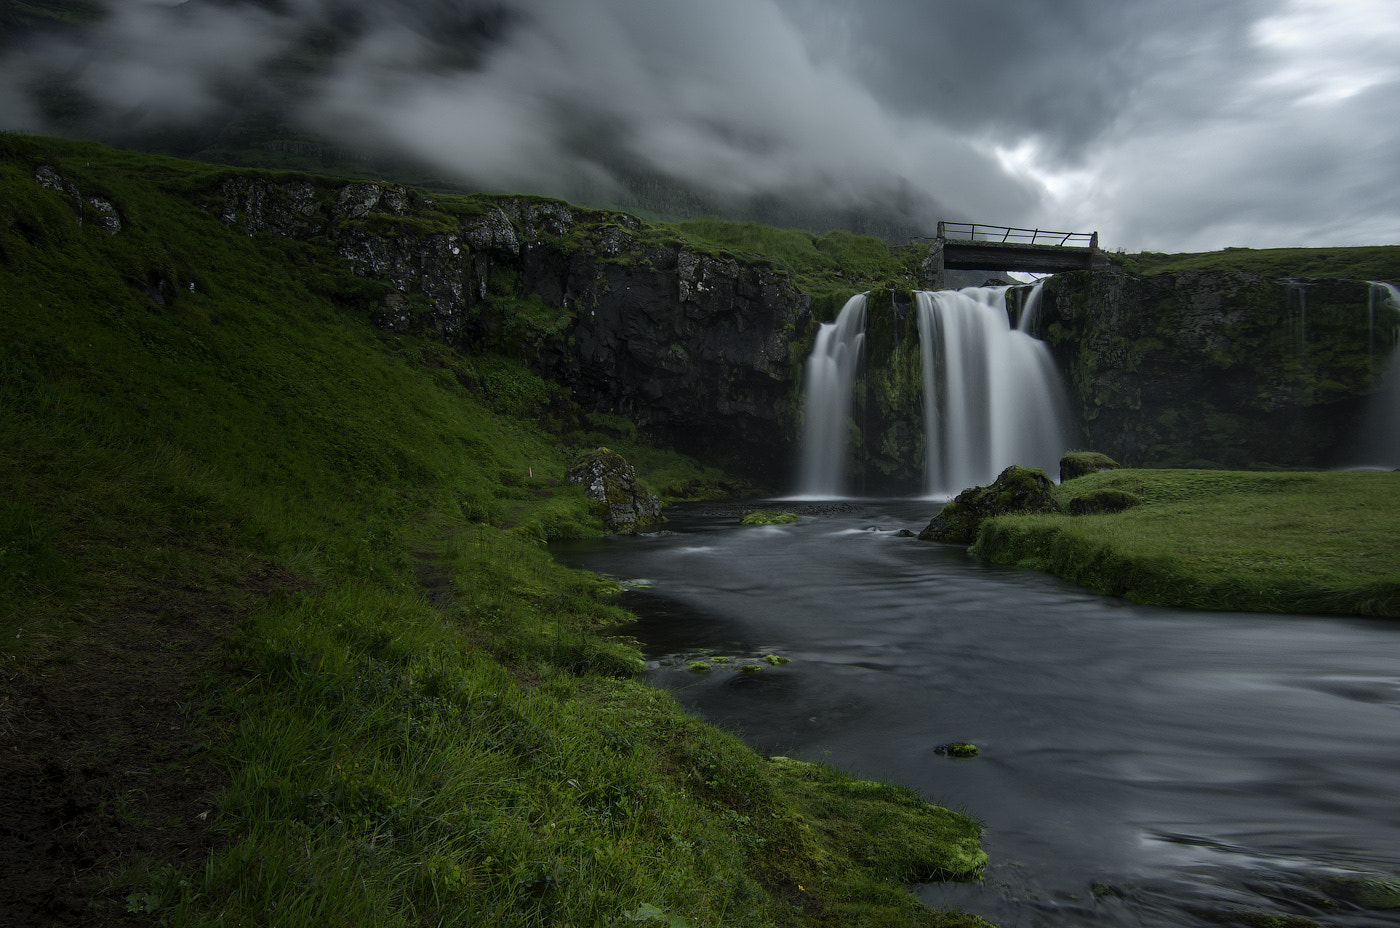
[798,294,865,497]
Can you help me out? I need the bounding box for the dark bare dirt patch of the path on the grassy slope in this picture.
[0,568,293,928]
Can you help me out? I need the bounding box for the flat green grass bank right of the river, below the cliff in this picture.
[972,470,1400,616]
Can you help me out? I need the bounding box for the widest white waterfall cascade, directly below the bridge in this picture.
[916,287,1070,497]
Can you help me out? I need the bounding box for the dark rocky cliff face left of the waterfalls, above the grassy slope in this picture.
[214,175,811,476]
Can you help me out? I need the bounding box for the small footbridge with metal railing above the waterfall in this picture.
[924,220,1112,290]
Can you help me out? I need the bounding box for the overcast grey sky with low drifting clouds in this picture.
[0,0,1400,252]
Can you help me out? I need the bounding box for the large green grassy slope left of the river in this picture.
[0,136,984,925]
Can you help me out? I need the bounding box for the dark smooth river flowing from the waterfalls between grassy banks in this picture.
[556,500,1400,928]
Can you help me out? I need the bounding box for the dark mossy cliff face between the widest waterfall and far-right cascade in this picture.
[1040,272,1396,467]
